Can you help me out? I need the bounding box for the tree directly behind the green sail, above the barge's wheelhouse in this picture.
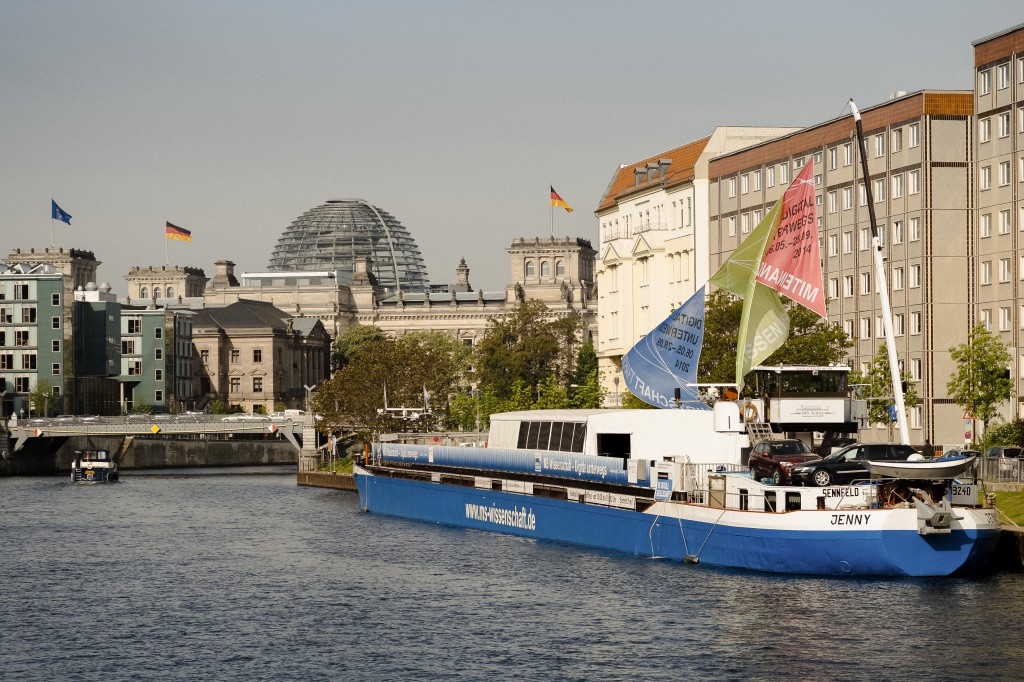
[697,289,853,388]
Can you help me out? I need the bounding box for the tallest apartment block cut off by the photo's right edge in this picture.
[966,25,1024,419]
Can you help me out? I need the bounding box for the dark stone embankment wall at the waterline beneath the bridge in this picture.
[0,436,299,476]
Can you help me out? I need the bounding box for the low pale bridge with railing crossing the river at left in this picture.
[8,415,307,452]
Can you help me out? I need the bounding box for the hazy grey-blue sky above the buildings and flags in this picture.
[0,0,1024,294]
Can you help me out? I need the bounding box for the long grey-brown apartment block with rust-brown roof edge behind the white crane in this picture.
[709,91,974,442]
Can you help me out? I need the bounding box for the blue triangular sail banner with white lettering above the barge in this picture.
[623,287,711,410]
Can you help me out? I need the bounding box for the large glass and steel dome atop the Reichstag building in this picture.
[268,199,429,292]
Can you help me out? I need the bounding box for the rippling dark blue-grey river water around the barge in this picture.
[0,468,1024,681]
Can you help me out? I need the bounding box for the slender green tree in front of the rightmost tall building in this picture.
[946,325,1014,440]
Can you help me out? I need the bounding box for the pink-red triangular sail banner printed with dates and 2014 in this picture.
[757,160,827,317]
